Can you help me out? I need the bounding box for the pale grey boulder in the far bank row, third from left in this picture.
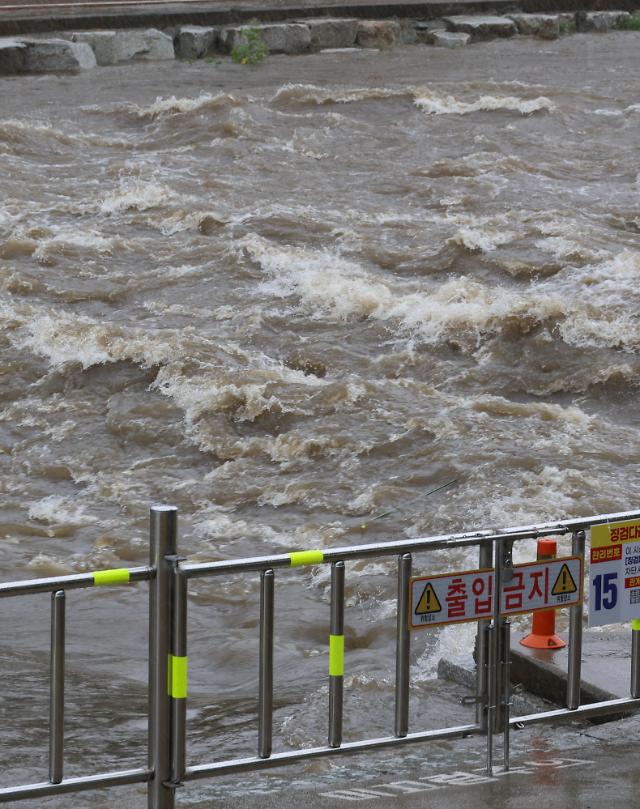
[71,28,175,65]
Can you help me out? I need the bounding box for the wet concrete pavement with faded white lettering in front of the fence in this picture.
[171,717,640,809]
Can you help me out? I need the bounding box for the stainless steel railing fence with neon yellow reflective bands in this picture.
[0,506,640,809]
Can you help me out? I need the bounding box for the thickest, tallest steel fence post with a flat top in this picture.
[147,506,178,809]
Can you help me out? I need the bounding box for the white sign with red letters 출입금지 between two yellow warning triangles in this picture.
[409,556,584,629]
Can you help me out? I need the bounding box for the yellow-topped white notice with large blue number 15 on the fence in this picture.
[589,520,640,626]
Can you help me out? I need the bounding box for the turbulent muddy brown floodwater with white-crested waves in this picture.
[0,33,640,807]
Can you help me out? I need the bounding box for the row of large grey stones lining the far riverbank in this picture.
[0,11,631,75]
